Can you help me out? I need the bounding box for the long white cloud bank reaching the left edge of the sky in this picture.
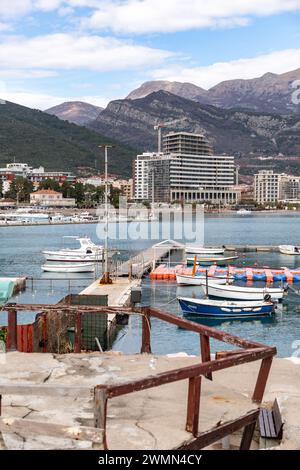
[0,34,174,72]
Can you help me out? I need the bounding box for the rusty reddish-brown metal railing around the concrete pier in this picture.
[3,304,276,449]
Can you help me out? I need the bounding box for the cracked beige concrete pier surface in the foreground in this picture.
[0,352,300,450]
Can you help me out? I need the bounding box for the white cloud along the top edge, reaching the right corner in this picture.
[83,0,300,34]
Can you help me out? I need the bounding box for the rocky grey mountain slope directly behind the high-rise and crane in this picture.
[89,91,300,174]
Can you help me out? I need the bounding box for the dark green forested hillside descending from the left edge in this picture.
[0,102,136,177]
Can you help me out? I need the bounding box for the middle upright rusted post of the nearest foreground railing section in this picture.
[186,376,202,437]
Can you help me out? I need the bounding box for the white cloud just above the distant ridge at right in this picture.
[151,49,300,89]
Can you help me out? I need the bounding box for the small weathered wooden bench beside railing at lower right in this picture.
[259,400,284,440]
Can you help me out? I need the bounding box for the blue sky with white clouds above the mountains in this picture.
[0,0,300,110]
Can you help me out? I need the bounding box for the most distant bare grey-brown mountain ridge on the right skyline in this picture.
[127,68,300,114]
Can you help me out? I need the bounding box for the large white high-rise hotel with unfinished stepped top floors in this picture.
[134,132,240,204]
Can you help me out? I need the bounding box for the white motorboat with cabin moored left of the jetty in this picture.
[43,237,103,263]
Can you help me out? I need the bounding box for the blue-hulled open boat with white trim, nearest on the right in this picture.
[177,297,275,318]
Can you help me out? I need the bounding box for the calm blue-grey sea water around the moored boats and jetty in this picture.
[0,213,300,357]
